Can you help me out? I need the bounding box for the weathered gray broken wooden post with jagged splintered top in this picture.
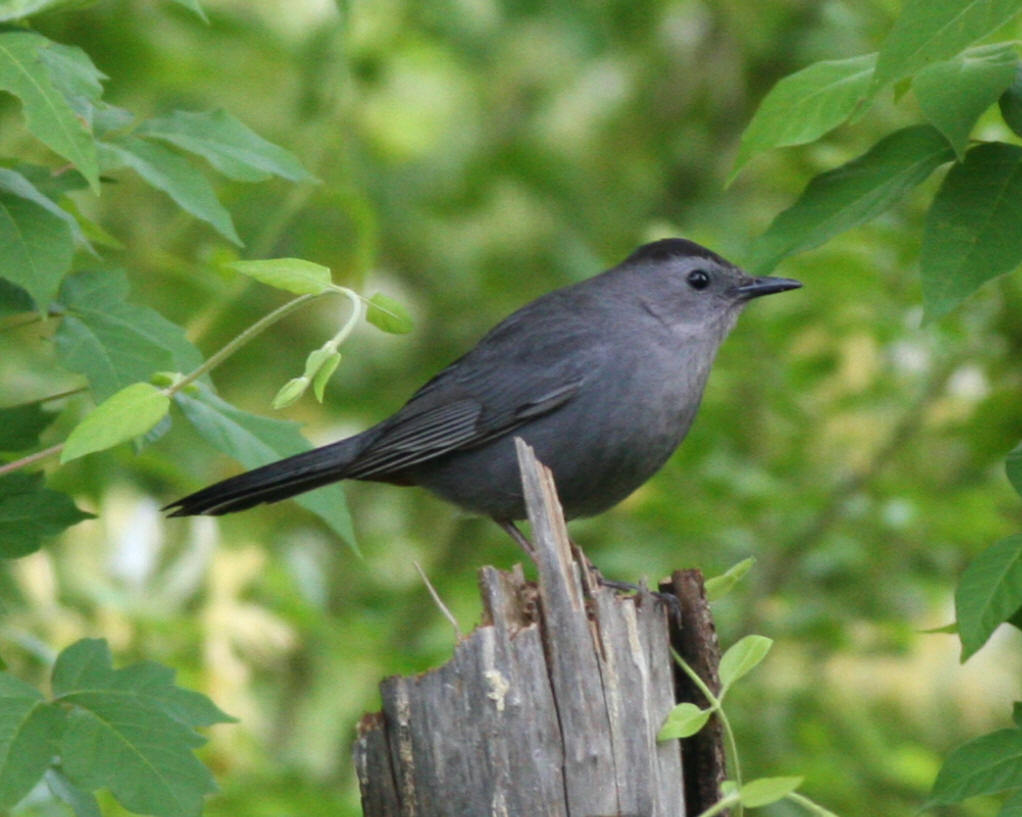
[354,440,718,817]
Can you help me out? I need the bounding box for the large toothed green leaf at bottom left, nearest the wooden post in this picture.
[52,639,222,817]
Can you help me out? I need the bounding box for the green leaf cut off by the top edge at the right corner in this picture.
[873,0,1022,89]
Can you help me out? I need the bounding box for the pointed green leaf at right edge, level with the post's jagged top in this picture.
[955,535,1022,662]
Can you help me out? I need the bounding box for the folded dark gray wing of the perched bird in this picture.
[344,296,608,480]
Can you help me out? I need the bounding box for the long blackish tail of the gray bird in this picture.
[164,435,365,516]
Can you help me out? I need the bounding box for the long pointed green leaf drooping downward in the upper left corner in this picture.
[0,31,99,193]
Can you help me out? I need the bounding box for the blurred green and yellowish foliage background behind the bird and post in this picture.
[0,0,1022,817]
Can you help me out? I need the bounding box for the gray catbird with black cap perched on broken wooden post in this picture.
[168,238,801,542]
